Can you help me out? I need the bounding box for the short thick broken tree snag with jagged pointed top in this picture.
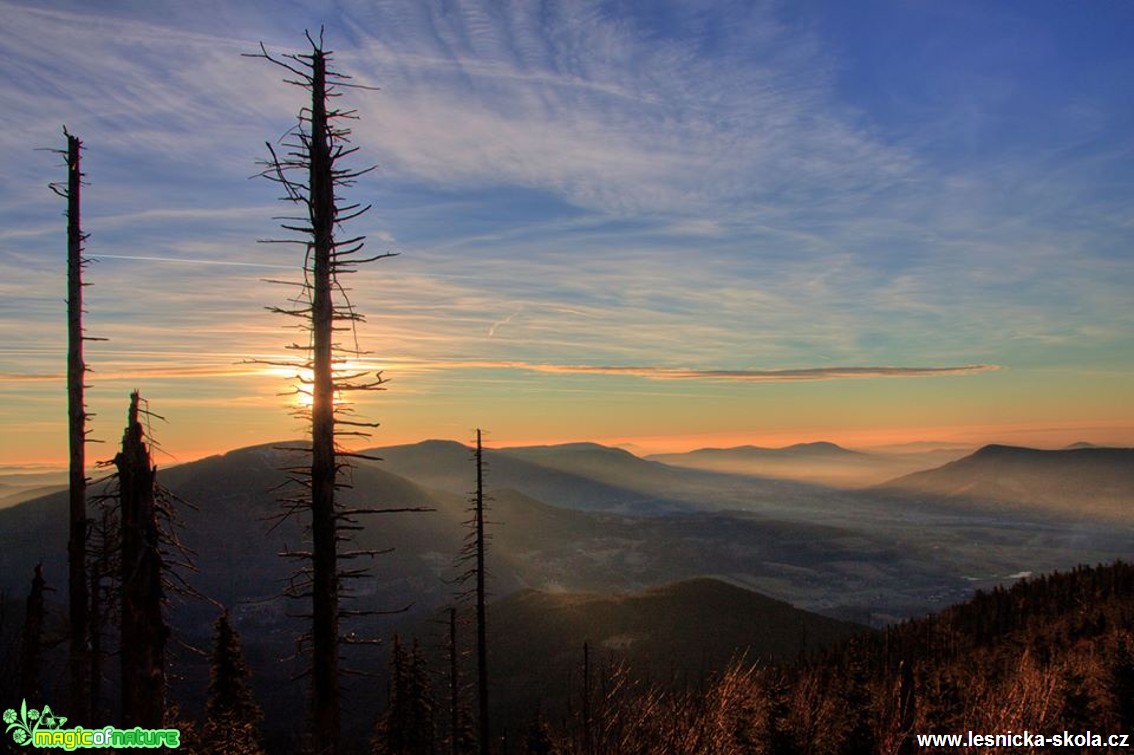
[115,391,169,729]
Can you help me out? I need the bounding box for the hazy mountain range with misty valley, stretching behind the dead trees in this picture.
[0,441,1134,739]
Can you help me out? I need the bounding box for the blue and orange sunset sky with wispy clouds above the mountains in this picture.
[0,0,1134,467]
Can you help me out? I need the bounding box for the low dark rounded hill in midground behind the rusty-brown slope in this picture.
[446,578,865,724]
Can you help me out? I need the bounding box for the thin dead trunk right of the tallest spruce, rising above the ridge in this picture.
[457,429,492,755]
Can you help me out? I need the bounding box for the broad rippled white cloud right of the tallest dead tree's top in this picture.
[337,2,913,214]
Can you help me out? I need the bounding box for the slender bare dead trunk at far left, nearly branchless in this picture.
[64,129,91,723]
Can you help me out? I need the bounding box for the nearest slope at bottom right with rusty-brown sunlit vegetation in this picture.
[496,555,1134,755]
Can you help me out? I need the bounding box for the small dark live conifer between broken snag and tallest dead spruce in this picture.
[201,610,263,755]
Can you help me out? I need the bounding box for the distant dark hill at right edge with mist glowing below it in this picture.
[878,446,1134,521]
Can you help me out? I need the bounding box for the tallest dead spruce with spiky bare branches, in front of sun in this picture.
[249,33,393,753]
